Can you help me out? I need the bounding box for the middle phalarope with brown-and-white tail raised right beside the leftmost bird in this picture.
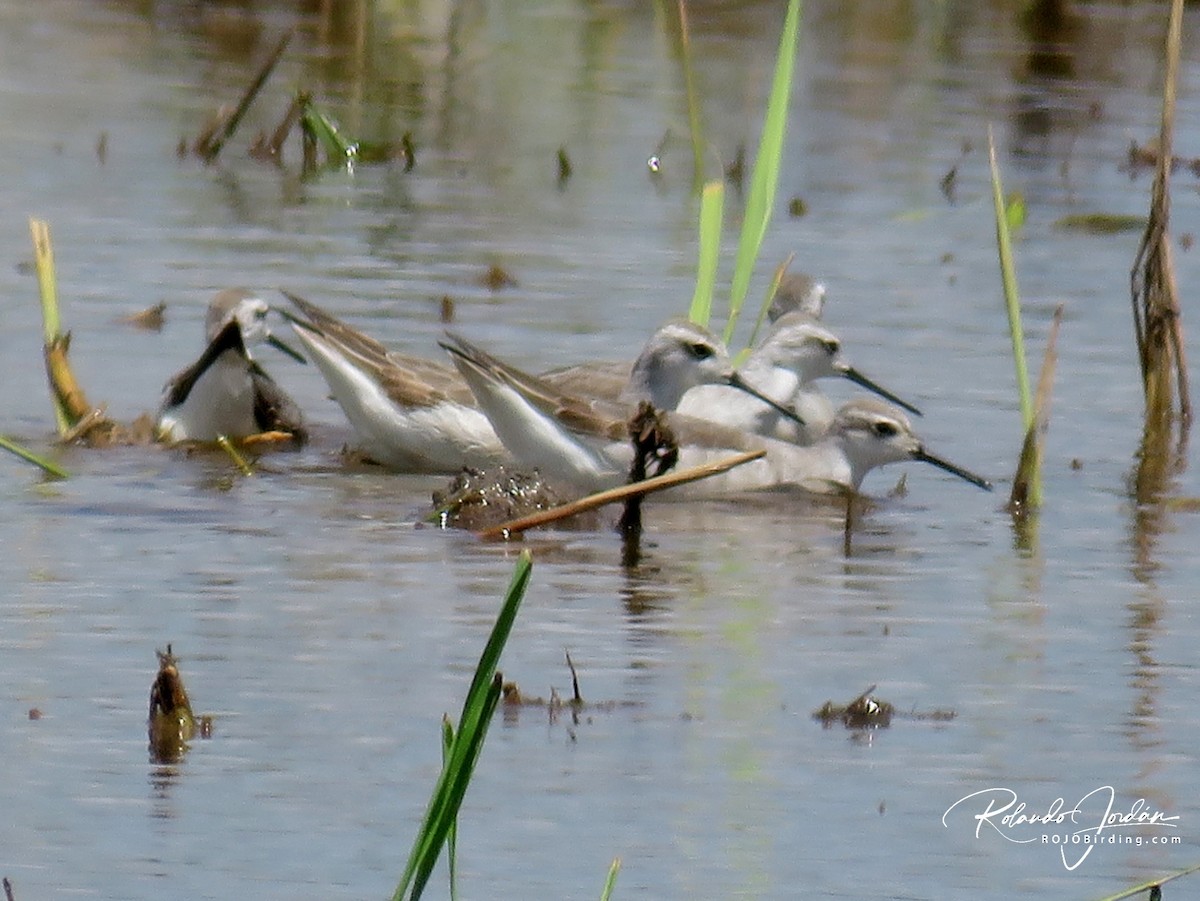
[283,292,794,473]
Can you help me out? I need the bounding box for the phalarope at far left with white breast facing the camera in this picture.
[157,288,306,443]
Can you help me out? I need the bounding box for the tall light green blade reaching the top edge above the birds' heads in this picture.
[725,0,800,344]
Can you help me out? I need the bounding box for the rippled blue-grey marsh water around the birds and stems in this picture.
[0,0,1200,901]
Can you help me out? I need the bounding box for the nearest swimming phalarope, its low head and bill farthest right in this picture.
[443,337,991,495]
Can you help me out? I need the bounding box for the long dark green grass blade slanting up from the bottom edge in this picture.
[392,551,533,901]
